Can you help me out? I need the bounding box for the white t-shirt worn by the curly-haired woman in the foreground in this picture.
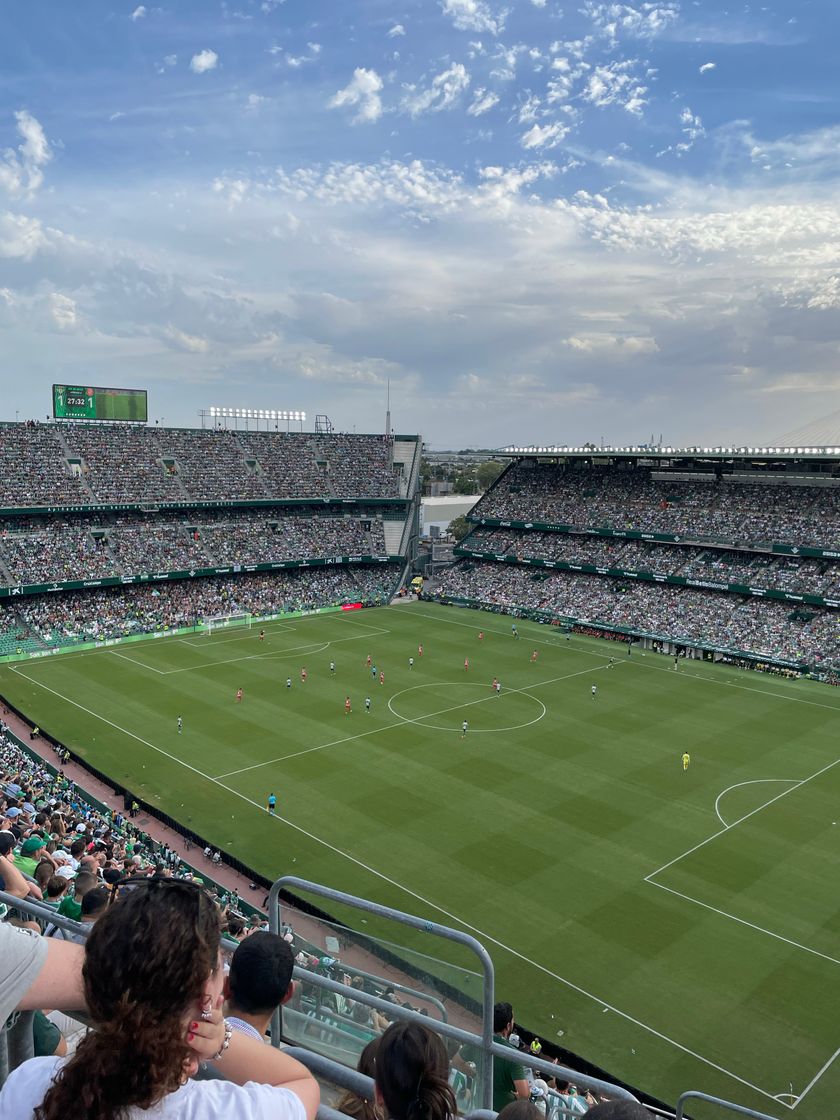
[0,1057,306,1120]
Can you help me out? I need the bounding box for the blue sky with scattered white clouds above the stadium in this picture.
[0,0,840,447]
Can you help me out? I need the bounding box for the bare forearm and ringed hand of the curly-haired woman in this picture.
[187,1008,320,1120]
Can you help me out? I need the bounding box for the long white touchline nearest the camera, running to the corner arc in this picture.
[4,665,791,1108]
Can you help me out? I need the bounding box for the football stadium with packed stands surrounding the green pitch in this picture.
[0,414,840,1118]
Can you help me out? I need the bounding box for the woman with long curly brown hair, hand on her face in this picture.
[0,878,319,1120]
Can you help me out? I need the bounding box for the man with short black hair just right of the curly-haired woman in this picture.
[224,931,295,1042]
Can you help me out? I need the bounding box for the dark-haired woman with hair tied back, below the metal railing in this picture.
[374,1023,458,1120]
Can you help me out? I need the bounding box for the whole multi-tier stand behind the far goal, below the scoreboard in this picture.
[0,421,417,656]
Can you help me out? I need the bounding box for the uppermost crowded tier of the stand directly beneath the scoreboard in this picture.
[0,423,401,508]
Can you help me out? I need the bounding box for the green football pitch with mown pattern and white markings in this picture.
[0,603,840,1120]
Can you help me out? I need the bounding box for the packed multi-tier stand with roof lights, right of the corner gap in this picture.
[433,458,840,681]
